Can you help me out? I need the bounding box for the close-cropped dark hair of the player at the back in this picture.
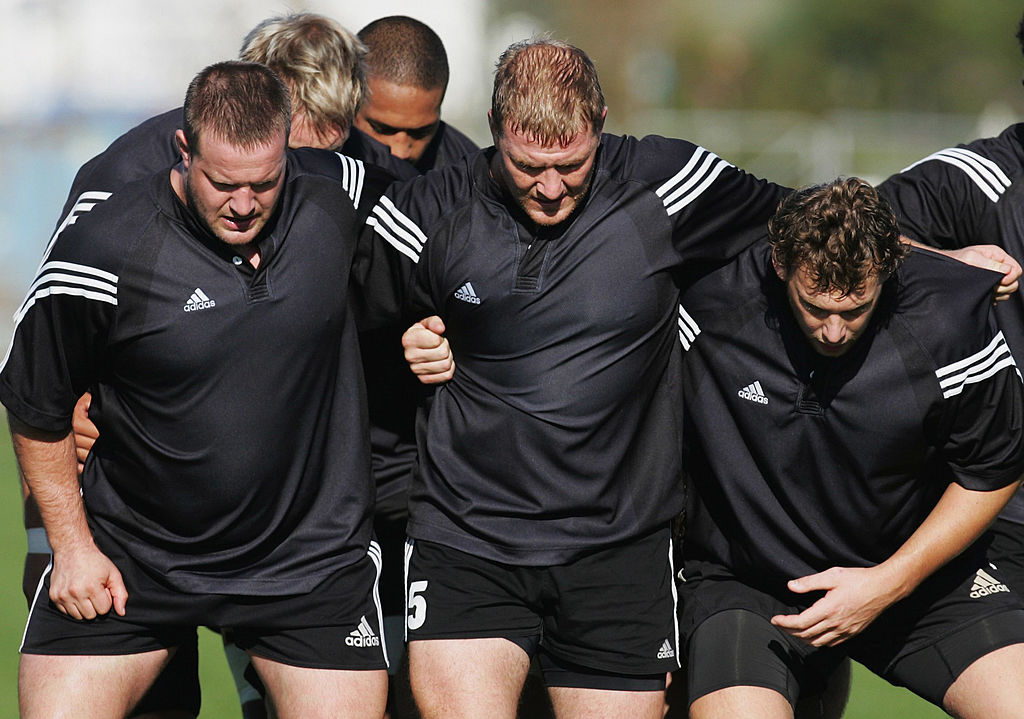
[359,15,449,90]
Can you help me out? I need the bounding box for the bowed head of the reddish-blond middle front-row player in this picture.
[488,39,607,226]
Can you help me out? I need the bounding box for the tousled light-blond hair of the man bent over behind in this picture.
[239,12,368,141]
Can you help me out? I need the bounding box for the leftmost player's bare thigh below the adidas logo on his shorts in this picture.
[252,654,387,719]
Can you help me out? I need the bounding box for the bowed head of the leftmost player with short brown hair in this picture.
[175,61,291,245]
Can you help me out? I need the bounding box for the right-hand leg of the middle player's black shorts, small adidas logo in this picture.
[541,525,680,690]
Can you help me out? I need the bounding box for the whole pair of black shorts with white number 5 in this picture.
[406,527,679,690]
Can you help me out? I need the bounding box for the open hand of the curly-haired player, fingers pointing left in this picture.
[771,566,894,646]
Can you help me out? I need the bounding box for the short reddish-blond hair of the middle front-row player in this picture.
[490,38,604,146]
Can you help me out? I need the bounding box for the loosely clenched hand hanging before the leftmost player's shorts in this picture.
[50,545,128,620]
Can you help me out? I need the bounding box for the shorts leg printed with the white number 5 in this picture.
[406,540,542,642]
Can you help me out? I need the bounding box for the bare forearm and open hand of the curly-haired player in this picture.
[772,481,1020,646]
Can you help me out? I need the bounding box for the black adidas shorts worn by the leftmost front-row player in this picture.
[20,543,387,670]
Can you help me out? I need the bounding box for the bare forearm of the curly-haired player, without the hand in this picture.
[877,481,1019,598]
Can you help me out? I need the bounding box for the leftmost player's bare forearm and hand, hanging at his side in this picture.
[8,415,128,620]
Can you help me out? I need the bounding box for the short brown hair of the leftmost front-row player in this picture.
[183,60,292,156]
